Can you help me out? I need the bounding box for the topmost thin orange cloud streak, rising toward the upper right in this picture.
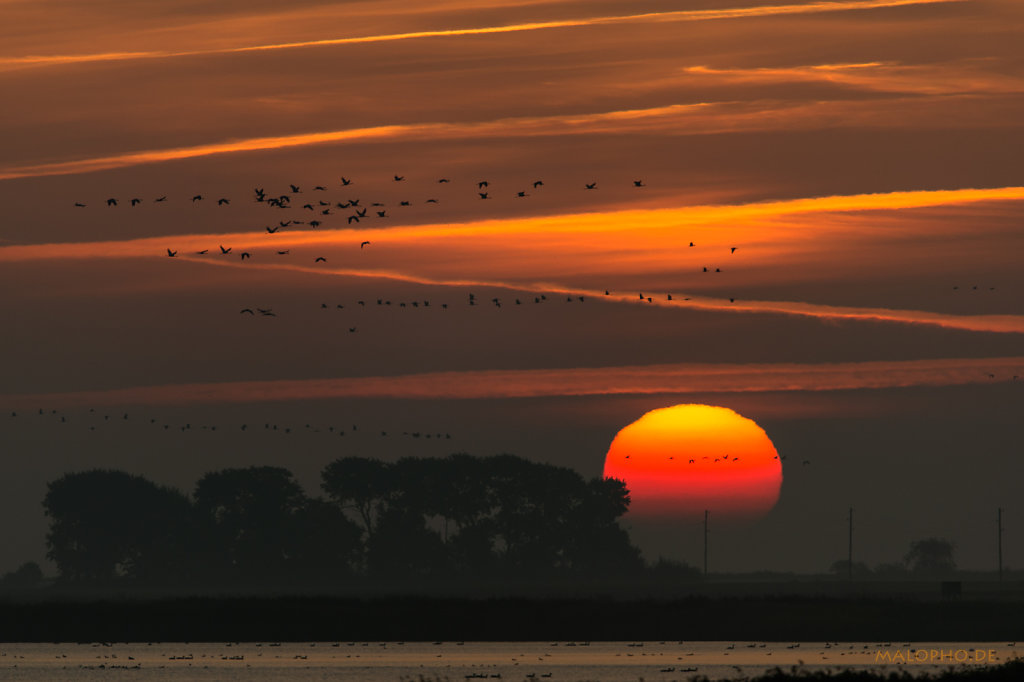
[0,0,965,70]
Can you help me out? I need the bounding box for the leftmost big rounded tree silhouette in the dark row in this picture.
[43,469,193,583]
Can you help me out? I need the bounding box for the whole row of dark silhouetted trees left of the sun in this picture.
[43,455,643,586]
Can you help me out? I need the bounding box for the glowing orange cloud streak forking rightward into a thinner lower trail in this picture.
[0,187,1024,334]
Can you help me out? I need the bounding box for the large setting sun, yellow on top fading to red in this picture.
[604,404,782,518]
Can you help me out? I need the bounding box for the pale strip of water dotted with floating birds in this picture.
[0,642,1024,682]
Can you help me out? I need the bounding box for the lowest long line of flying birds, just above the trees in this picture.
[4,408,453,440]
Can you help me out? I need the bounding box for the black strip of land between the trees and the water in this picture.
[0,596,1024,642]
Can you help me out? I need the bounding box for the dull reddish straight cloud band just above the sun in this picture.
[6,357,1024,408]
